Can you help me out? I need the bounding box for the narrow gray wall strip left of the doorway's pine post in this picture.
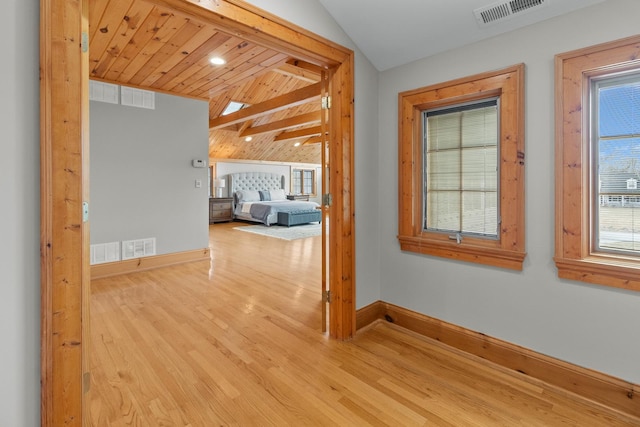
[0,0,40,426]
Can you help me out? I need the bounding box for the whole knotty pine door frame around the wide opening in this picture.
[40,0,355,426]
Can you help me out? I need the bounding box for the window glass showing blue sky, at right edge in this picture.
[593,75,640,255]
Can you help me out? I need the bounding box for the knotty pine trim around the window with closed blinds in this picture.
[398,64,526,270]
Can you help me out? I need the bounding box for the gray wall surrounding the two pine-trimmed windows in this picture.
[378,0,640,383]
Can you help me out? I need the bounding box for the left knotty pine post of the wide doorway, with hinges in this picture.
[40,0,88,426]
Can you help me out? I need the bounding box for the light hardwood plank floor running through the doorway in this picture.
[88,223,640,426]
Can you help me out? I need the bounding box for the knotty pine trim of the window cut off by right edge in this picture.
[554,36,640,291]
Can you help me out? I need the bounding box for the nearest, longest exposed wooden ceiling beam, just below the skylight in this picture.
[209,83,321,129]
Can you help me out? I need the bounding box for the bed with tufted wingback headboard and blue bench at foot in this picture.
[228,172,322,226]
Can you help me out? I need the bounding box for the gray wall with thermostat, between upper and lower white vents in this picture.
[90,93,209,254]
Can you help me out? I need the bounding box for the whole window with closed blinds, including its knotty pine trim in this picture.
[398,64,526,270]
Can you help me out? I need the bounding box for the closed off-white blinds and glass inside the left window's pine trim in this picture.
[423,98,499,239]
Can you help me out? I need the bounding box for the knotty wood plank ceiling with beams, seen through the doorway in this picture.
[89,0,321,163]
